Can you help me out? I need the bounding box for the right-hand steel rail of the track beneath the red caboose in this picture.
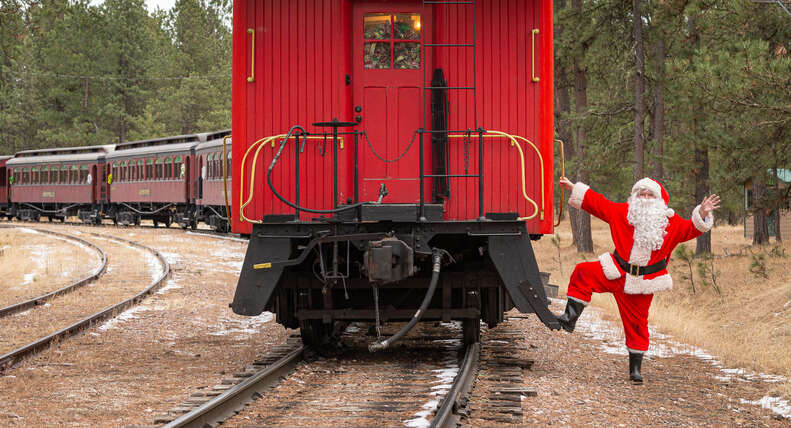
[429,343,481,428]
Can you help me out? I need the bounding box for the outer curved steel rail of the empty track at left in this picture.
[0,233,170,372]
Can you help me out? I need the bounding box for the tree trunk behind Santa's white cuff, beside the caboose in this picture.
[569,0,593,253]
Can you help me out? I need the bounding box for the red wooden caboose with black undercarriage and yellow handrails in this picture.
[232,0,557,348]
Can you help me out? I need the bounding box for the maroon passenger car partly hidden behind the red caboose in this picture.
[193,129,232,232]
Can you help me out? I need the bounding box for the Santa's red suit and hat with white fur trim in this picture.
[567,178,714,353]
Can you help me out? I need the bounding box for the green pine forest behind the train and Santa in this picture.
[0,0,791,247]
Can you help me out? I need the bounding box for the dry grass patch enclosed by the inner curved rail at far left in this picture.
[0,229,100,307]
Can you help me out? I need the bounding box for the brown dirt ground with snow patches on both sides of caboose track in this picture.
[0,222,791,427]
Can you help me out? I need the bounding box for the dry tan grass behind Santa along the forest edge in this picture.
[536,219,791,397]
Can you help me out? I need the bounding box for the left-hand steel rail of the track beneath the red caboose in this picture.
[165,345,307,428]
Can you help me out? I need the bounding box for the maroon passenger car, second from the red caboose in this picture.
[107,135,200,228]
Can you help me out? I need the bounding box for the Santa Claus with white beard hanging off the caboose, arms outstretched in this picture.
[558,178,720,384]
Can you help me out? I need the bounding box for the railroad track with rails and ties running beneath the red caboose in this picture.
[153,326,480,427]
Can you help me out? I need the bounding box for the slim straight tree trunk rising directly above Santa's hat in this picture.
[632,0,645,181]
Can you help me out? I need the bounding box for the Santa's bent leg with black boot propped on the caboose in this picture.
[558,262,624,332]
